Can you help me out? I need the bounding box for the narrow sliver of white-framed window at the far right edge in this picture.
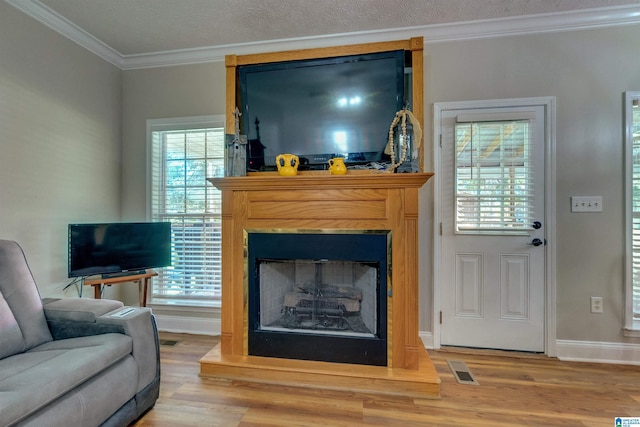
[625,91,640,336]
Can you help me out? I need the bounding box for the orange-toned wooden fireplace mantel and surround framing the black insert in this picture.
[201,171,439,395]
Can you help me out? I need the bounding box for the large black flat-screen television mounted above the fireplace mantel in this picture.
[238,50,410,170]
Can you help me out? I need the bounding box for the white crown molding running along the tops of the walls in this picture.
[5,0,640,70]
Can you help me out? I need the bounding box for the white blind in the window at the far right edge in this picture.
[627,93,640,330]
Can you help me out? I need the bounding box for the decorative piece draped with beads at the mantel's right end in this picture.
[384,106,422,173]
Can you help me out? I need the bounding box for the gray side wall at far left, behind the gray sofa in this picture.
[0,1,122,296]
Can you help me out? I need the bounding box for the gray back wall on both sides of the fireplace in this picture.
[123,26,640,342]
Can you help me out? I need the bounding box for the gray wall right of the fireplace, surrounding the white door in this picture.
[421,26,640,342]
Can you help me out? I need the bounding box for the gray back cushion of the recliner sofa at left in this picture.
[0,240,52,359]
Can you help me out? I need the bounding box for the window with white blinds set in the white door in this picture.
[455,115,535,234]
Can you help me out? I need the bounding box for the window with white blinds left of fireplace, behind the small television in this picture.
[147,116,225,304]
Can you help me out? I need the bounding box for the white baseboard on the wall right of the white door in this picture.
[556,340,640,365]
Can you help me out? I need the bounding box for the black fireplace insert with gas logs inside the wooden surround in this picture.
[245,230,391,366]
